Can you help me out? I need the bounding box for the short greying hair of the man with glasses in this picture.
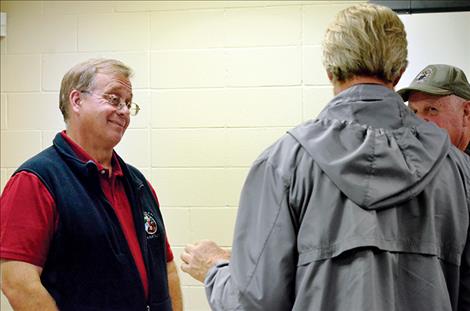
[59,58,133,121]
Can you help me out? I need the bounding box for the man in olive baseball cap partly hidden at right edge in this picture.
[398,64,470,155]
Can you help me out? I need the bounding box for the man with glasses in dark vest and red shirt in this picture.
[0,59,182,311]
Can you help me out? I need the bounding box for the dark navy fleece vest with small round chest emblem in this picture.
[17,134,172,311]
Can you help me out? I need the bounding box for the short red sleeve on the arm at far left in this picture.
[0,171,58,267]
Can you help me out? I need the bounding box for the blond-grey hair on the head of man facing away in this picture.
[323,4,408,83]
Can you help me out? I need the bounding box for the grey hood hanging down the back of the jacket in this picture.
[289,84,450,210]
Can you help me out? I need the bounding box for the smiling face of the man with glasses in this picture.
[77,73,132,149]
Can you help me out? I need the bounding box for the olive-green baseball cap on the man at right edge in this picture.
[397,64,470,101]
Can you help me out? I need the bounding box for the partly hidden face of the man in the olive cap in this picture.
[408,92,470,150]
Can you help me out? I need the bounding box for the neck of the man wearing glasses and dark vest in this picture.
[66,126,113,174]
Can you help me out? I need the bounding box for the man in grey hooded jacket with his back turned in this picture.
[181,4,470,311]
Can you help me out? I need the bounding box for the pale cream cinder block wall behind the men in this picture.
[0,1,362,310]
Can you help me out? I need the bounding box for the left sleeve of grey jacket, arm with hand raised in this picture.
[205,158,298,311]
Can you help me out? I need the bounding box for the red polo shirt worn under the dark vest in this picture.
[0,131,173,297]
